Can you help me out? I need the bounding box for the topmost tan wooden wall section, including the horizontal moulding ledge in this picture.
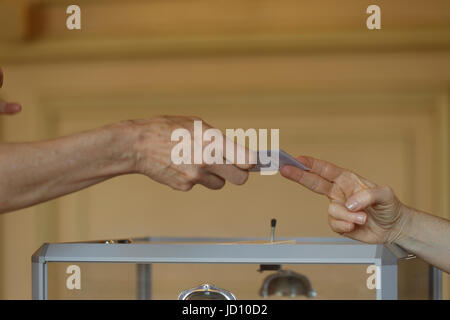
[0,0,450,63]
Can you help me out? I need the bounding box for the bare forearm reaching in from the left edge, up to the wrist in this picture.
[0,122,134,213]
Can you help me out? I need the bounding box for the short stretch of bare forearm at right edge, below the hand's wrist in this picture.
[395,208,450,273]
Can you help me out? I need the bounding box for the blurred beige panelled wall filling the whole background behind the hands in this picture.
[0,0,450,299]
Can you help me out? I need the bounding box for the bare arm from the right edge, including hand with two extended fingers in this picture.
[281,157,450,272]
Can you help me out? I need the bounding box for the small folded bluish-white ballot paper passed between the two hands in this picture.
[249,150,311,172]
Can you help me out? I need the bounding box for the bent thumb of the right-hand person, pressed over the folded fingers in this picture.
[345,187,394,211]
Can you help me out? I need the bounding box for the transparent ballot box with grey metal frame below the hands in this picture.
[31,237,440,299]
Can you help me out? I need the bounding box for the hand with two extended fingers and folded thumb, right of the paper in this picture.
[280,157,408,243]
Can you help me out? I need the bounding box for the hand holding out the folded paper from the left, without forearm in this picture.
[131,116,251,191]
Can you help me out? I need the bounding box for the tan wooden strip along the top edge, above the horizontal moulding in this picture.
[25,0,450,37]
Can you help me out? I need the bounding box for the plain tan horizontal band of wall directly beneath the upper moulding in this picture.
[3,52,450,95]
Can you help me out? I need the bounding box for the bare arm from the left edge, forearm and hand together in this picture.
[0,116,250,213]
